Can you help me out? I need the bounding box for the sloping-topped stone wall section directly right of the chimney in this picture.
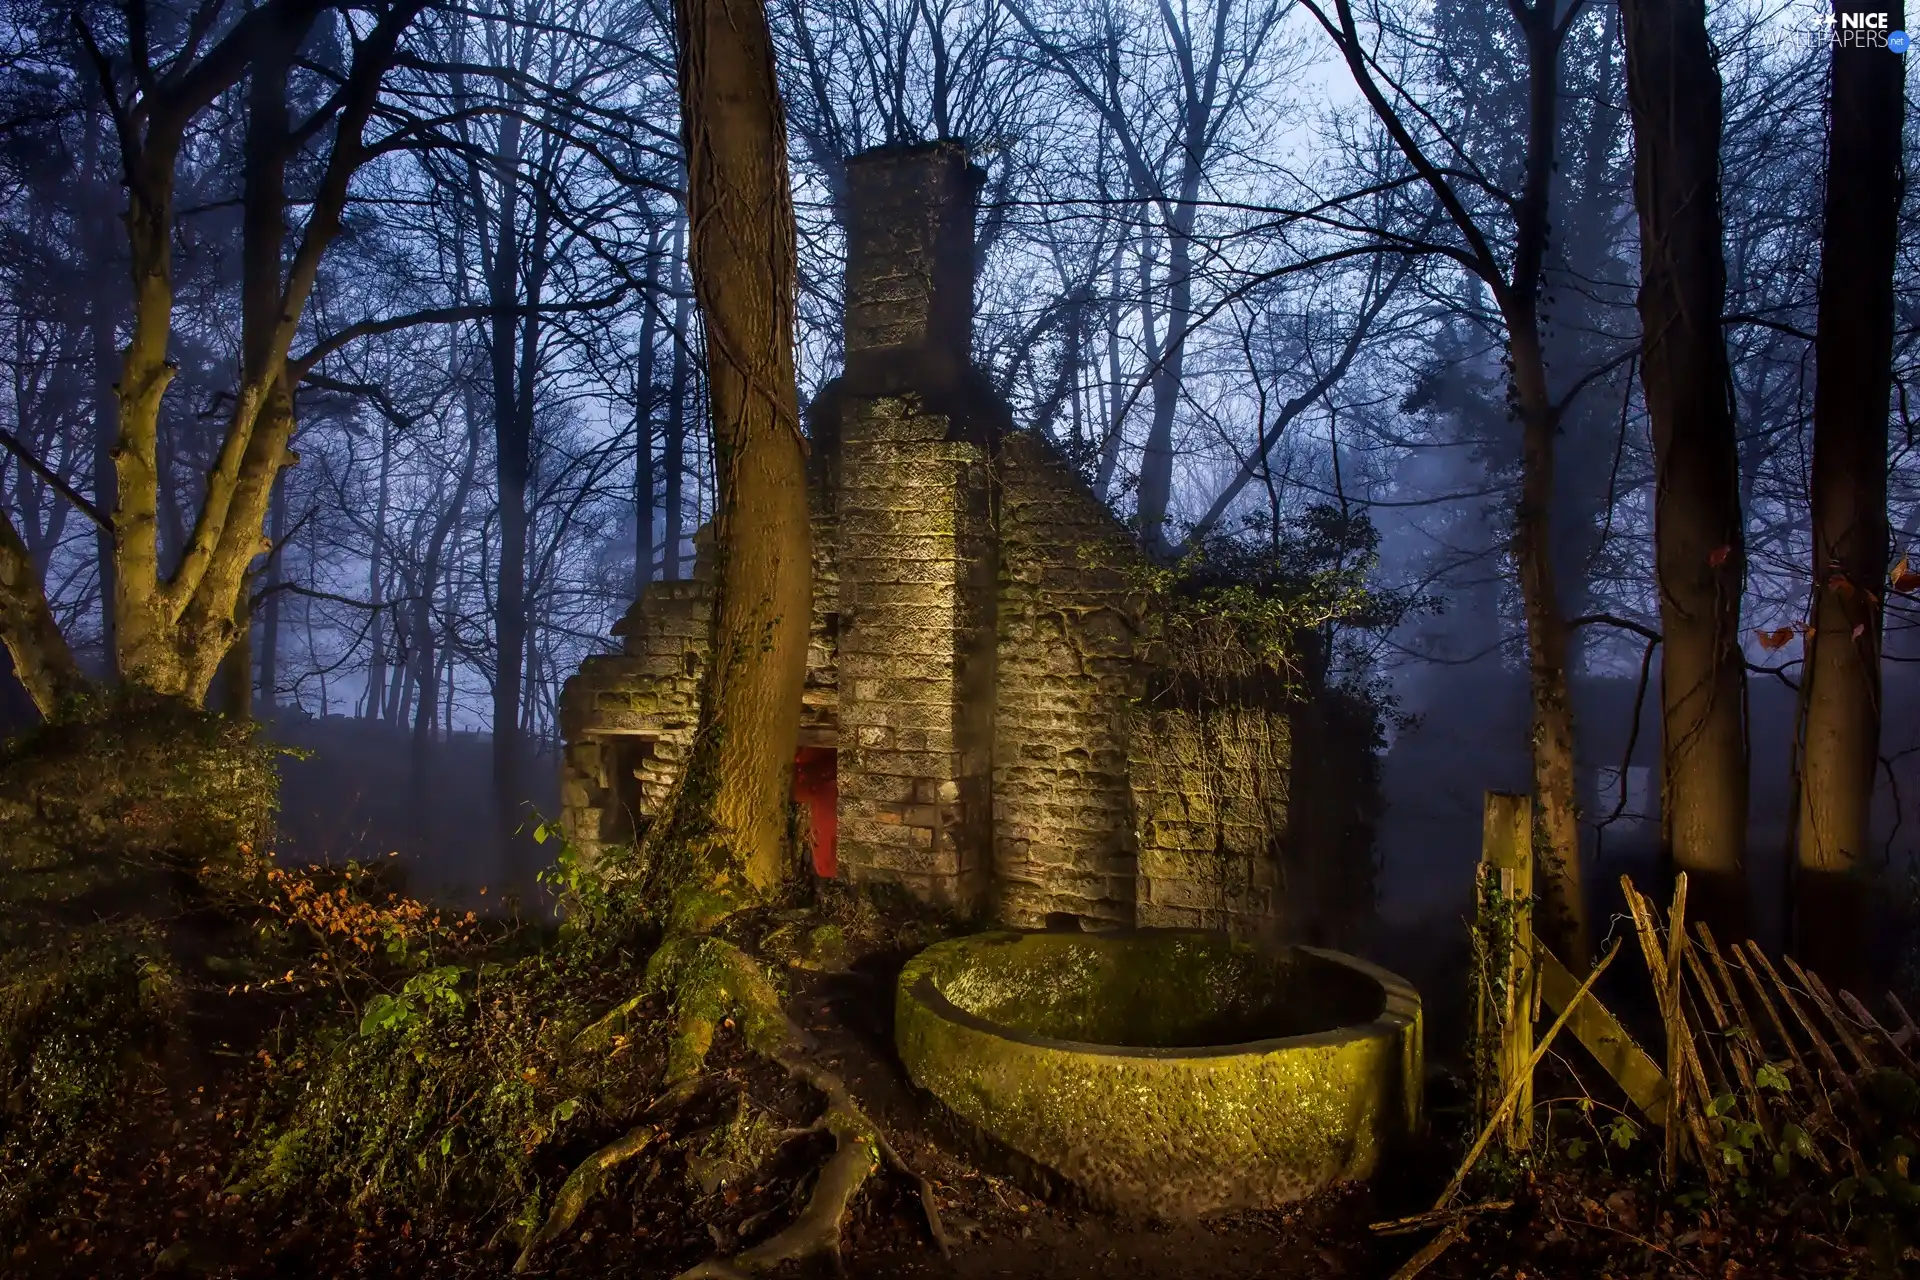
[993,434,1144,925]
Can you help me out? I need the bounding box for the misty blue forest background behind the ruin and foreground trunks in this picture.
[0,0,1920,951]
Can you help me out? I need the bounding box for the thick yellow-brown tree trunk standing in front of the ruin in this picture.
[674,0,812,909]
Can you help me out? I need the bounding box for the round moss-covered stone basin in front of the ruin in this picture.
[895,929,1421,1219]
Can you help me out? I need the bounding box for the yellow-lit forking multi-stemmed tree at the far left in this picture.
[0,0,426,712]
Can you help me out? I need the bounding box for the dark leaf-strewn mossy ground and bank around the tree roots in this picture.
[0,706,1896,1280]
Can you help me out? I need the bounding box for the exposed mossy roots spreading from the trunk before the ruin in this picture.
[529,936,950,1280]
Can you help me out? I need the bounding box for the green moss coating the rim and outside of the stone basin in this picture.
[895,933,1419,1217]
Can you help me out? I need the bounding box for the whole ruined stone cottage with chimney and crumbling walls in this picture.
[561,142,1367,936]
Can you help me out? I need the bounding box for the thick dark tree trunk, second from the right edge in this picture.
[1620,0,1747,938]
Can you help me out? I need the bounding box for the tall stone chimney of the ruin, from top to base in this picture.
[835,142,995,912]
